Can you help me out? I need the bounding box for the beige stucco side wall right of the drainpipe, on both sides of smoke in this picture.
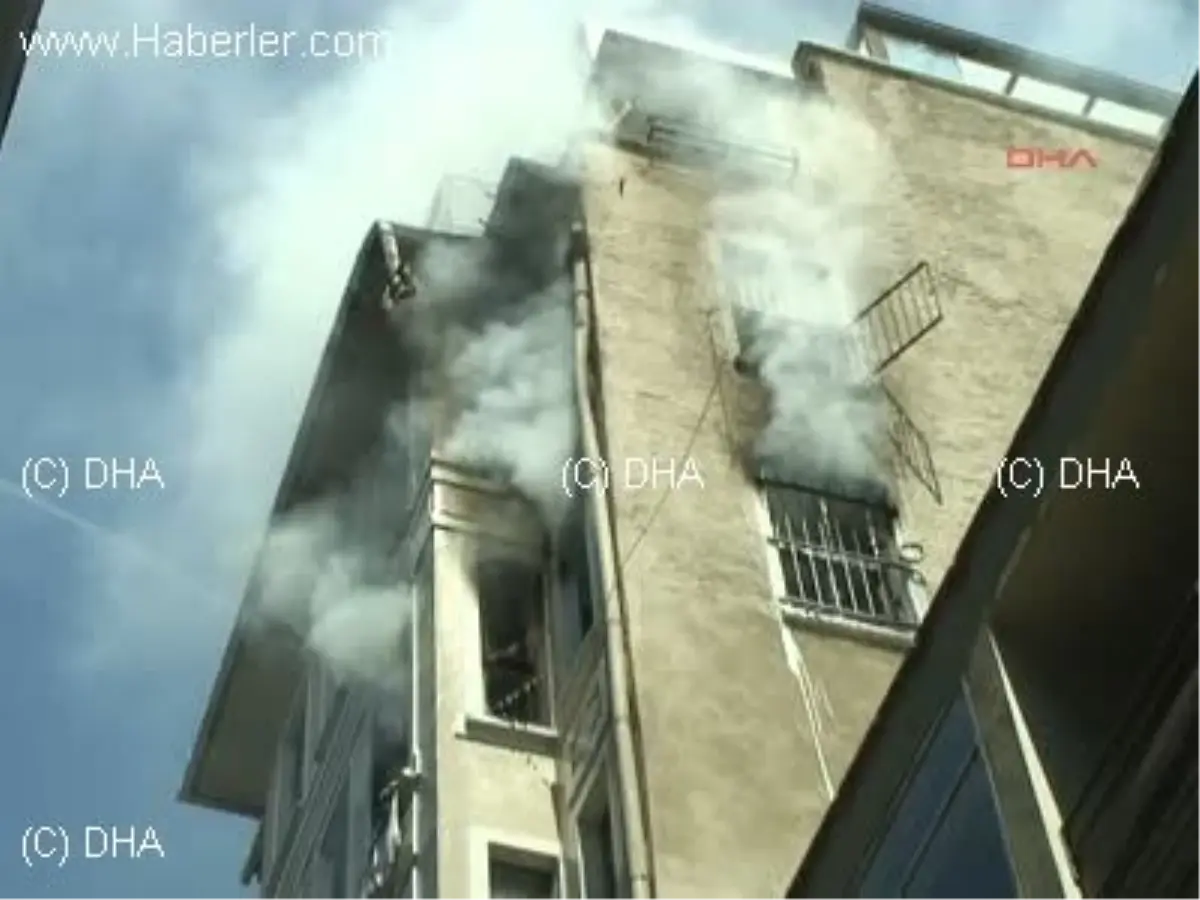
[584,47,1150,900]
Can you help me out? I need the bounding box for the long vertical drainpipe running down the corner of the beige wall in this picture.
[572,220,655,900]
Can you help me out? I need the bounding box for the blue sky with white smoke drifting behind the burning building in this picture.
[0,0,1200,900]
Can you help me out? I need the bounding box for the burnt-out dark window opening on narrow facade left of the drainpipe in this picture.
[475,557,551,726]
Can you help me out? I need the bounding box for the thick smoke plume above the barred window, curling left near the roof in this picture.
[624,51,888,493]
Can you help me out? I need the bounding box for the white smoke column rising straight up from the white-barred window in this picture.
[713,100,888,490]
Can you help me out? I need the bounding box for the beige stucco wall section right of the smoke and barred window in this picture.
[817,55,1153,593]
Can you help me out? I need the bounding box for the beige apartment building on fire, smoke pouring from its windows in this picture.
[182,10,1177,900]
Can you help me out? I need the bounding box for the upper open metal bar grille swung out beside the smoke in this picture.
[858,262,943,373]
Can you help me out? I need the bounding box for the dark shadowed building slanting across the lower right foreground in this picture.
[788,63,1200,900]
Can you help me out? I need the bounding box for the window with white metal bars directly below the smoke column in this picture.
[762,481,917,628]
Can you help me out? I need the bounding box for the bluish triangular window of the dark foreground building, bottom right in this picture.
[858,691,1019,900]
